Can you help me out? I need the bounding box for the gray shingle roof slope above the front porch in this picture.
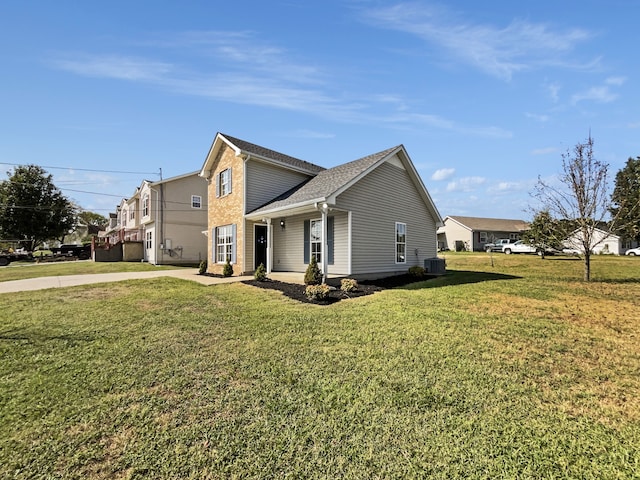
[250,146,399,213]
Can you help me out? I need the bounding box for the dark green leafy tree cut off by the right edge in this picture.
[609,157,640,242]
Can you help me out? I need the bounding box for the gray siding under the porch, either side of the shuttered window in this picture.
[273,212,350,275]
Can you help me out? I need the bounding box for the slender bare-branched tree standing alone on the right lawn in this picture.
[533,135,611,282]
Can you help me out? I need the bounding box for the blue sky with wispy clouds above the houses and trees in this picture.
[0,0,640,219]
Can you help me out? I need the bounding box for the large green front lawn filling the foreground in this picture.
[0,253,640,479]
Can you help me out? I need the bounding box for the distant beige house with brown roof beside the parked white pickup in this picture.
[438,216,529,251]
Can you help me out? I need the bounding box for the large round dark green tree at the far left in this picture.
[0,165,76,250]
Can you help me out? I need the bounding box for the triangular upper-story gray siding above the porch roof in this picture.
[245,160,309,213]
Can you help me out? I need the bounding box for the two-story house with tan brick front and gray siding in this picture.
[200,133,442,278]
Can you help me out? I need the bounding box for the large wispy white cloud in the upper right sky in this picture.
[365,3,593,80]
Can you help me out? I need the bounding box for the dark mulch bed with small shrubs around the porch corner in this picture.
[242,274,431,305]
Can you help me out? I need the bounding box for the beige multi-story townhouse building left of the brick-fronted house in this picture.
[95,172,208,265]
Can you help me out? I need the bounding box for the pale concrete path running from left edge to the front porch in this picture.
[0,268,253,293]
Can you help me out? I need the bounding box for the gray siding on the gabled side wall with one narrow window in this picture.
[337,162,437,275]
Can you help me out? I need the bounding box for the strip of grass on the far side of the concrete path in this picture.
[0,260,193,282]
